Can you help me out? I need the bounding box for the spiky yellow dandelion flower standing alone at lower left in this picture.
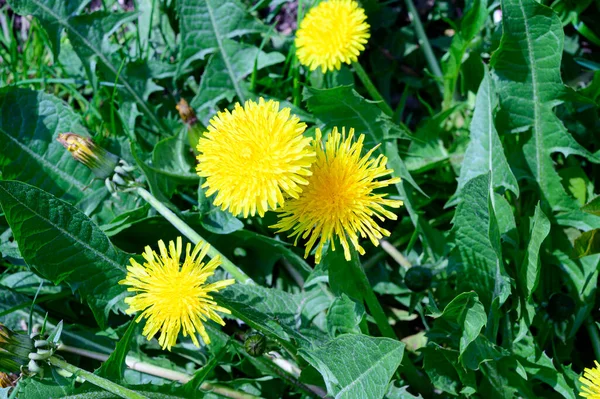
[119,237,235,350]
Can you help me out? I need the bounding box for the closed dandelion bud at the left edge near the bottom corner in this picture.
[0,324,35,373]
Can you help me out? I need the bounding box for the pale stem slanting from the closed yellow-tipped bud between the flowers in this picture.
[136,187,254,284]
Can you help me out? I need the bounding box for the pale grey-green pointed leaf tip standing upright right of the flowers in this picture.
[455,68,519,203]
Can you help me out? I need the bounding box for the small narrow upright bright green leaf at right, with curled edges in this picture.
[519,204,550,300]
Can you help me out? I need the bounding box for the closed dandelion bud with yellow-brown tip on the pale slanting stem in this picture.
[56,133,119,179]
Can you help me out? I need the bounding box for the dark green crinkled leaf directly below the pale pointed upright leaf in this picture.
[451,174,510,309]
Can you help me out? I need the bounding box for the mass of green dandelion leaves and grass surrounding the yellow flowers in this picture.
[0,0,600,399]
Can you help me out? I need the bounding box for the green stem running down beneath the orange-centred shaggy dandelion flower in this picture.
[348,246,433,398]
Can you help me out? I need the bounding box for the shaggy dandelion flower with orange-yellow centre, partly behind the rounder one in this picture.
[272,128,402,263]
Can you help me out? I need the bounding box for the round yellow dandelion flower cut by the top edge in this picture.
[296,0,371,72]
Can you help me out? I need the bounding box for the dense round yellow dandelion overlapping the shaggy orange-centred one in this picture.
[197,98,315,217]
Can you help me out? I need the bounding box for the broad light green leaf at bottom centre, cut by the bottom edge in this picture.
[300,334,404,399]
